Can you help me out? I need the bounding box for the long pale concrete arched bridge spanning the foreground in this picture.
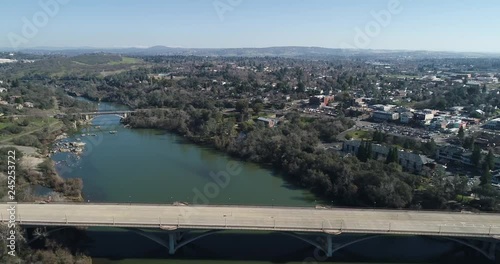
[1,204,500,260]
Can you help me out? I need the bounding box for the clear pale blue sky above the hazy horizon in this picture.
[0,0,500,52]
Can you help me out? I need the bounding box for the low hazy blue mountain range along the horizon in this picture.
[0,46,500,59]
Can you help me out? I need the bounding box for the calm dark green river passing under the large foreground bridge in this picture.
[48,98,494,264]
